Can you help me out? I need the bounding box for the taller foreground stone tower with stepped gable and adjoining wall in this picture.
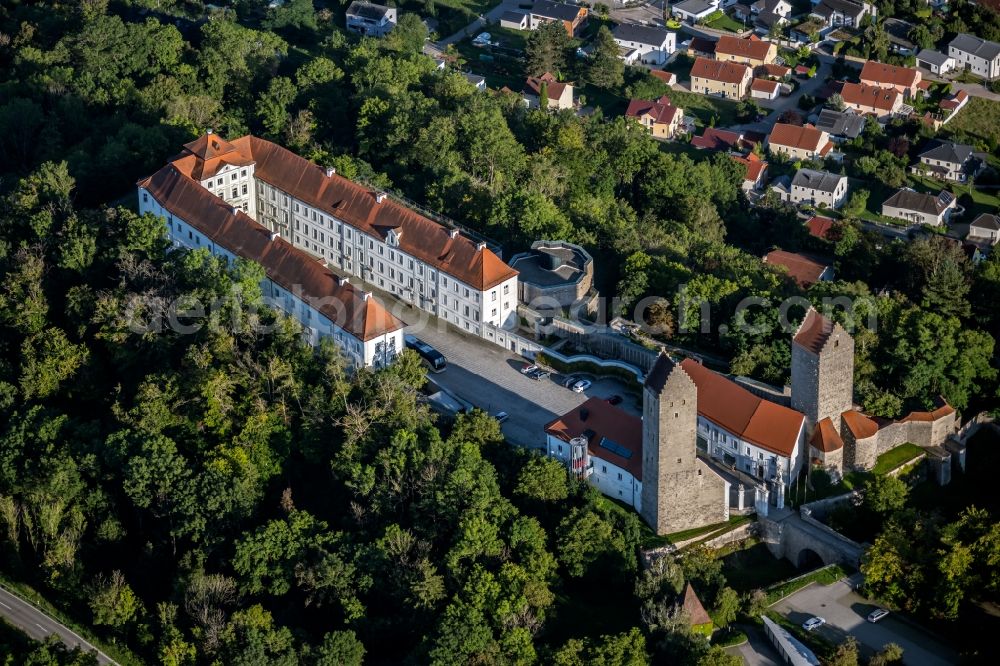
[642,353,729,534]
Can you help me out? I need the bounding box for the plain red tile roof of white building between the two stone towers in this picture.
[681,359,805,456]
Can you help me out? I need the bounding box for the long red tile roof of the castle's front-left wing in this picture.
[139,164,405,340]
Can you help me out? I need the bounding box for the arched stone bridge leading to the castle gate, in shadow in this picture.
[758,507,865,568]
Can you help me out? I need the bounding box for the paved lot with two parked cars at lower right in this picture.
[773,580,958,666]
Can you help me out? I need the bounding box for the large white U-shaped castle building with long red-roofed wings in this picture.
[138,131,518,366]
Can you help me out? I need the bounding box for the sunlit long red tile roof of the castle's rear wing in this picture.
[209,135,517,290]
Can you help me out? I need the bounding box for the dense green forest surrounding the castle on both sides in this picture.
[0,0,1000,665]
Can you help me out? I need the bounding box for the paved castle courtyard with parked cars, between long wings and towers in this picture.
[403,313,640,448]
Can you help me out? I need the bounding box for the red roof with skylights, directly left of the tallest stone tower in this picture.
[545,398,642,481]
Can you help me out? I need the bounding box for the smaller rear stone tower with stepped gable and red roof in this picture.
[792,308,854,430]
